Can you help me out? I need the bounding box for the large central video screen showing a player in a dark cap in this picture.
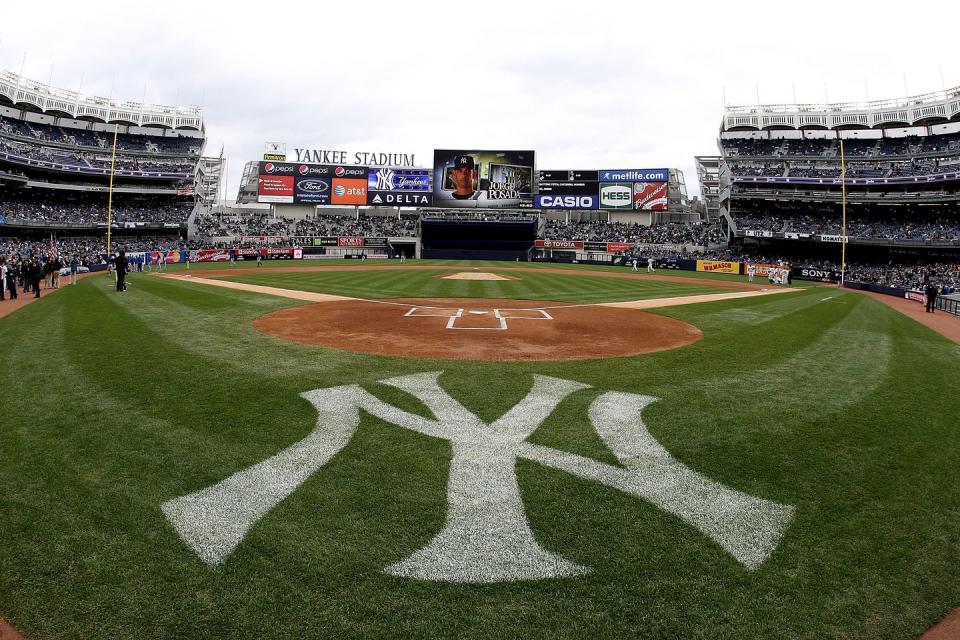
[433,149,534,209]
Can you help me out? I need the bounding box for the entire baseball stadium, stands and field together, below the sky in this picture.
[0,61,960,640]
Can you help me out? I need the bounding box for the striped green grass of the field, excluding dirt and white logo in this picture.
[0,263,960,640]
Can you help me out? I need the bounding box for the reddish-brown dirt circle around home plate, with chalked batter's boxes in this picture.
[254,298,703,360]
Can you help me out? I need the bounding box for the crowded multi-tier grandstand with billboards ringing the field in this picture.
[0,67,960,310]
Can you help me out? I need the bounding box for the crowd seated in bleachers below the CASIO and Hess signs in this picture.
[543,220,726,246]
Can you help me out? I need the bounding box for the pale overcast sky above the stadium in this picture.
[0,0,960,199]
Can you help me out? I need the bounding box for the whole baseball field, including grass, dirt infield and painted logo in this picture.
[0,261,960,640]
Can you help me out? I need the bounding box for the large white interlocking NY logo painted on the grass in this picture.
[162,372,793,582]
